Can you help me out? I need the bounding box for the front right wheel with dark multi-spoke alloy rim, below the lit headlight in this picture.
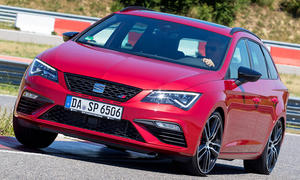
[177,112,223,176]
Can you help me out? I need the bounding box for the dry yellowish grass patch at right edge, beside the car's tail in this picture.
[280,74,300,97]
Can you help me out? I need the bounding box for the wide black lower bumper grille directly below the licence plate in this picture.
[39,106,144,142]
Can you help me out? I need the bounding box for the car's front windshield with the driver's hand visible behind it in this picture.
[77,14,231,70]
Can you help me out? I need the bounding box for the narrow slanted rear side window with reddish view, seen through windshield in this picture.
[121,23,147,50]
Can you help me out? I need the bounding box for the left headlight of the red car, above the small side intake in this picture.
[29,58,58,82]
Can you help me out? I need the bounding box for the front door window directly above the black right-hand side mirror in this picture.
[228,40,250,79]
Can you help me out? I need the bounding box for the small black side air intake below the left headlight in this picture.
[17,97,46,115]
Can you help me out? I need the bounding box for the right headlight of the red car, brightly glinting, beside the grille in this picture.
[142,91,201,110]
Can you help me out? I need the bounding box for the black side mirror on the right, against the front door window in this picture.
[235,66,261,86]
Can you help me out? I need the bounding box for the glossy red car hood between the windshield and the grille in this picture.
[38,41,218,90]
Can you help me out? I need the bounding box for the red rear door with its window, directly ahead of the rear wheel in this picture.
[245,40,277,152]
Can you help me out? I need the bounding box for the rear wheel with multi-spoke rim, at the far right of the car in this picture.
[244,120,284,175]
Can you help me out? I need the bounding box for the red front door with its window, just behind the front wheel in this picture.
[222,39,257,153]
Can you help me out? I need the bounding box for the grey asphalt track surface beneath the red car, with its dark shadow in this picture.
[0,96,300,180]
